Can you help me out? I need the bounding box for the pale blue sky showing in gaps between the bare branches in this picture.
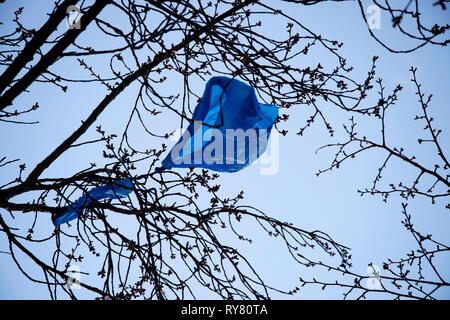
[0,1,450,299]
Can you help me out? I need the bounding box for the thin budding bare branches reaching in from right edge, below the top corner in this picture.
[301,68,450,299]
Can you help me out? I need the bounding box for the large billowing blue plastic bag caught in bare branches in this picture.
[156,77,278,172]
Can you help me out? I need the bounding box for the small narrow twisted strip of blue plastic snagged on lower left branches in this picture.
[52,179,133,226]
